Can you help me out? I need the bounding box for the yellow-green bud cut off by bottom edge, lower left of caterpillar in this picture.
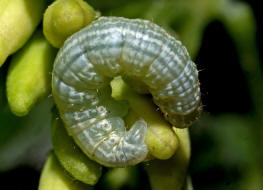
[38,153,93,190]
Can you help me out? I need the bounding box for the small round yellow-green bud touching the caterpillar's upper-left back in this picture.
[43,0,96,48]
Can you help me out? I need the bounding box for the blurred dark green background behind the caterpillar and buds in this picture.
[0,0,263,190]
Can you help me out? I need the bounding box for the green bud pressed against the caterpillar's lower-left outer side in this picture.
[52,112,102,185]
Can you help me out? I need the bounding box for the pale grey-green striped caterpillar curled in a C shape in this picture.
[52,17,201,167]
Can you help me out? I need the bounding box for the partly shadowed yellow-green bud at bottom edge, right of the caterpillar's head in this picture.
[145,128,190,190]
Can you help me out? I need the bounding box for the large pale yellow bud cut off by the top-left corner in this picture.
[0,0,47,66]
